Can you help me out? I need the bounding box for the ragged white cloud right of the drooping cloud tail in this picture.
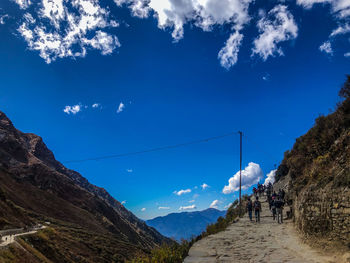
[252,5,298,60]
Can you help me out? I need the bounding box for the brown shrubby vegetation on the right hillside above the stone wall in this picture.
[276,75,350,192]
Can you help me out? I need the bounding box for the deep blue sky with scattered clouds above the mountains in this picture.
[0,0,350,219]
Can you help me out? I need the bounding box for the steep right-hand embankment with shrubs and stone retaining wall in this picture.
[275,77,350,249]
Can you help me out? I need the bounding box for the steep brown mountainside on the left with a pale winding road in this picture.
[0,111,171,262]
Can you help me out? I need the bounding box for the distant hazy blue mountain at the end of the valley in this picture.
[146,208,226,241]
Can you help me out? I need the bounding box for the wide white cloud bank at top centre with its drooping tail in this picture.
[114,0,253,69]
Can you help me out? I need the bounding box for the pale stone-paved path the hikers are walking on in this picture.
[184,197,339,263]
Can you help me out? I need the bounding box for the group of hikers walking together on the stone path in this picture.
[246,182,286,224]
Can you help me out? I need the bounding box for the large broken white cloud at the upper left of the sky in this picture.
[16,0,120,63]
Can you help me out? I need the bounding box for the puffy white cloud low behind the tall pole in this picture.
[222,162,263,194]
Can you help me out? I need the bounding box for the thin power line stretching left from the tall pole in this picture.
[64,132,238,163]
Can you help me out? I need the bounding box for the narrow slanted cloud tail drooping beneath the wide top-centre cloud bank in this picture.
[218,31,243,69]
